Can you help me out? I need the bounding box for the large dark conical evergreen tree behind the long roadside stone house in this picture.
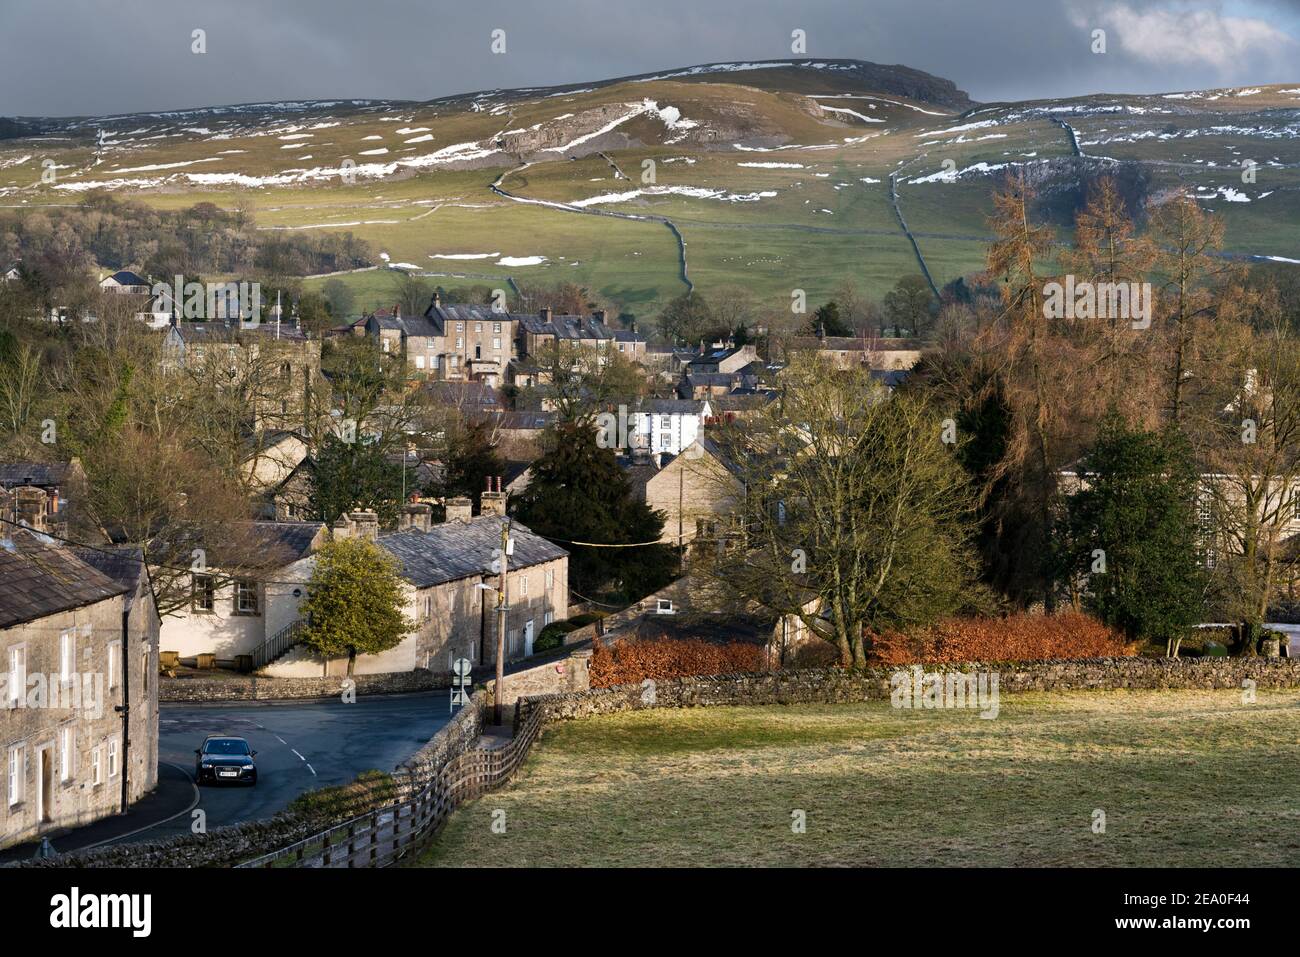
[514,423,677,597]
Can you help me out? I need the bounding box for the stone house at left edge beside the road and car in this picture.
[0,527,159,845]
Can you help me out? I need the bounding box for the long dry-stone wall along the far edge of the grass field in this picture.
[520,658,1300,722]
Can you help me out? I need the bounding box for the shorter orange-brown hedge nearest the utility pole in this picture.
[592,638,767,688]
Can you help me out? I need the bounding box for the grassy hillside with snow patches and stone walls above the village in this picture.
[0,60,1300,315]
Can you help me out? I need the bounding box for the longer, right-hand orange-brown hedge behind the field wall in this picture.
[871,611,1138,664]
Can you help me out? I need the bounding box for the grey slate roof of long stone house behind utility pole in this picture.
[378,515,568,588]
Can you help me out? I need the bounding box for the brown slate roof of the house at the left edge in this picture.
[0,525,127,628]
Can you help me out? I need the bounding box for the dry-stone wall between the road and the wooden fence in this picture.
[8,690,488,867]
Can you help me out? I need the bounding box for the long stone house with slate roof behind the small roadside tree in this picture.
[265,504,569,677]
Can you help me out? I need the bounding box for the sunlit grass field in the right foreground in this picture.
[419,690,1300,867]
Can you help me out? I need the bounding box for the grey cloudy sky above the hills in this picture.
[0,0,1300,116]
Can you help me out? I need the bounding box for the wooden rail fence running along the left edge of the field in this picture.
[237,709,542,867]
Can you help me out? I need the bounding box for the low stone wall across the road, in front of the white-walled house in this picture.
[159,668,451,702]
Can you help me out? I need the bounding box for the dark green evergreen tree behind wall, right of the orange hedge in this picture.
[1065,413,1204,654]
